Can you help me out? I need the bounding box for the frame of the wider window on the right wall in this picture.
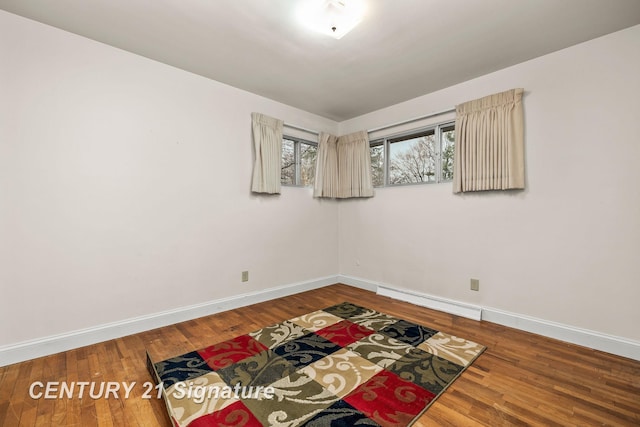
[369,120,455,188]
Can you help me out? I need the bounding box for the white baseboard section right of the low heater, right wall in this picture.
[482,307,640,361]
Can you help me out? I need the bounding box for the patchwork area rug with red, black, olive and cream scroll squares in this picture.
[147,302,485,427]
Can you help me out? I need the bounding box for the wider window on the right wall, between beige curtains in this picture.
[370,123,455,187]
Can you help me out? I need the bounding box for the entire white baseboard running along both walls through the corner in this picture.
[0,275,640,366]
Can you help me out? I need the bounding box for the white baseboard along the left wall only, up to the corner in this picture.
[0,276,340,366]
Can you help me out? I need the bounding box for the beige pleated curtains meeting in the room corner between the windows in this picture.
[313,131,373,199]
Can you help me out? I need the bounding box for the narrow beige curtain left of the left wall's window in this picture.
[251,113,284,194]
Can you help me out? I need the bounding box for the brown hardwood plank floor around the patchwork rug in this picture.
[0,285,640,427]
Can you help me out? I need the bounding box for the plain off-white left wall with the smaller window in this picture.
[0,11,338,346]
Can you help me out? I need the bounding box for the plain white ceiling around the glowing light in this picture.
[0,0,640,121]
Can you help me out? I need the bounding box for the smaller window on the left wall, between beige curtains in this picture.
[280,136,318,186]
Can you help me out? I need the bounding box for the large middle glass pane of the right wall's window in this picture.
[389,131,436,184]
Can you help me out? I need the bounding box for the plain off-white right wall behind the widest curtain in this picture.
[339,26,640,340]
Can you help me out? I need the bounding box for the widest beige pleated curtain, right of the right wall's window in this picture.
[453,89,524,193]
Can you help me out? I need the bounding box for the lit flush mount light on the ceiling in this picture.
[298,0,364,39]
